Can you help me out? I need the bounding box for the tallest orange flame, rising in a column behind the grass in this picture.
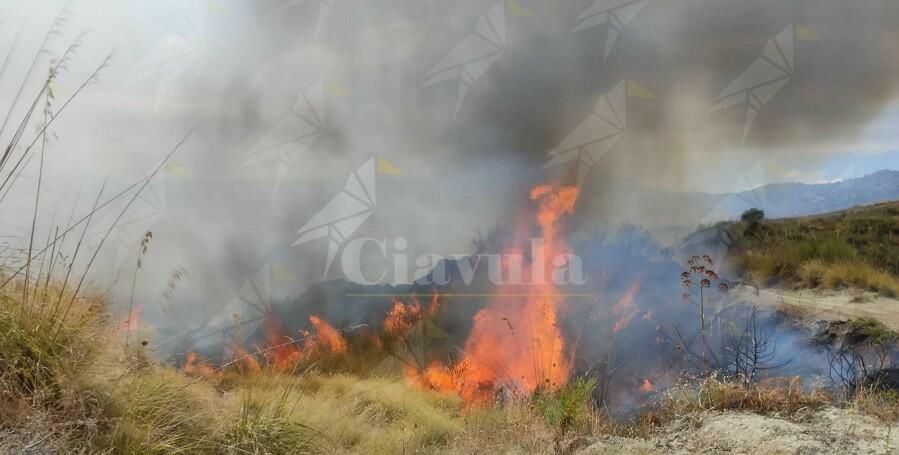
[407,185,578,403]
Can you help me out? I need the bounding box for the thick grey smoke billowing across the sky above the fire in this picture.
[2,0,899,323]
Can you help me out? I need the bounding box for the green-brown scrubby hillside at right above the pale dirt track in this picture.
[723,202,899,297]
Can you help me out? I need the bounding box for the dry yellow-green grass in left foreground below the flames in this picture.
[0,280,568,454]
